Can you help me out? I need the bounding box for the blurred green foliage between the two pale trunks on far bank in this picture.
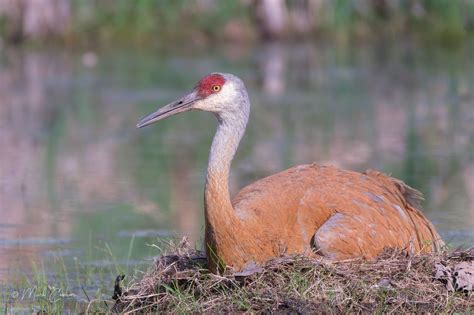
[69,0,252,42]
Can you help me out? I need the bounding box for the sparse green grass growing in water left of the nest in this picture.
[0,237,150,314]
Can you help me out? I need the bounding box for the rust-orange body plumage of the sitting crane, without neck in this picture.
[206,164,443,269]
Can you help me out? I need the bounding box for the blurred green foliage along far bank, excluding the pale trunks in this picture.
[0,0,474,45]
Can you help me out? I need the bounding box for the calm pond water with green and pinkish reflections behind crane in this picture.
[0,43,474,292]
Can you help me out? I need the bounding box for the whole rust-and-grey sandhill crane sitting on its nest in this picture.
[137,73,443,271]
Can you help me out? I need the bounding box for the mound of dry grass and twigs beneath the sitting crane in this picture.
[114,241,474,313]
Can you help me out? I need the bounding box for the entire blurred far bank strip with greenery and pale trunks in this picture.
[0,0,474,47]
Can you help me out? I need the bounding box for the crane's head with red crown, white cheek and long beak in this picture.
[137,73,250,128]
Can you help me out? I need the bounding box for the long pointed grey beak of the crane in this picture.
[137,91,201,128]
